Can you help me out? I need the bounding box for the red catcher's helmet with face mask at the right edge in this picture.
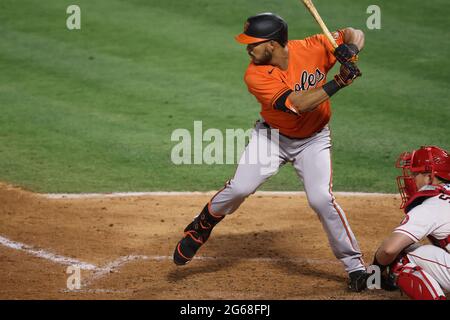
[396,146,450,209]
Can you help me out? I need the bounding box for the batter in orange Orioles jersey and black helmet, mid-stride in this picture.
[174,13,366,291]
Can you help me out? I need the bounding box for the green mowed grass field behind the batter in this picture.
[0,0,450,192]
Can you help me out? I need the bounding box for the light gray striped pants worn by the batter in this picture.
[209,121,365,273]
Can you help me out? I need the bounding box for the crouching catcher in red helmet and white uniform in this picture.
[374,146,450,300]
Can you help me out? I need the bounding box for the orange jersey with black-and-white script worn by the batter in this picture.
[244,30,344,138]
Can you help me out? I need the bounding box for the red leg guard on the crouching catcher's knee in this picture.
[394,263,446,300]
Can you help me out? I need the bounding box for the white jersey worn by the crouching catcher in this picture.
[394,185,450,252]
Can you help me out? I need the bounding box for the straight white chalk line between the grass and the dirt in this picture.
[40,191,398,199]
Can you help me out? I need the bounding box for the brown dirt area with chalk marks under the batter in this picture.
[0,184,414,299]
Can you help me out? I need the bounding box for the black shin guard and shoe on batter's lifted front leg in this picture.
[173,204,225,266]
